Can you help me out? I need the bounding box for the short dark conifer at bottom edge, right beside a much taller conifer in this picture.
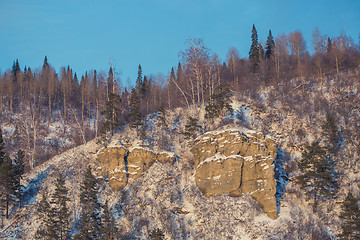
[100,201,119,240]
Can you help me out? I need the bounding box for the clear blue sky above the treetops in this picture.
[0,0,360,83]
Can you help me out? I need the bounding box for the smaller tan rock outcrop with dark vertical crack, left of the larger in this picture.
[95,142,175,191]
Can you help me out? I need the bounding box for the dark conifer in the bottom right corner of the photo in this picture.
[339,192,360,239]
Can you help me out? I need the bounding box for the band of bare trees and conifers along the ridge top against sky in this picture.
[0,25,360,171]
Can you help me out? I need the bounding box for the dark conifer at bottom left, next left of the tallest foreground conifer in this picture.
[51,173,70,239]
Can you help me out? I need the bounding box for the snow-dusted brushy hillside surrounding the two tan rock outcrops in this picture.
[0,68,360,239]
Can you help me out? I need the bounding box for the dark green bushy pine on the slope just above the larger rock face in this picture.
[205,86,233,121]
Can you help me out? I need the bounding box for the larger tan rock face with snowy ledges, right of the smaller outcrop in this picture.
[191,129,277,219]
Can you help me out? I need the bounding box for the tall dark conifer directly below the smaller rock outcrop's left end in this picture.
[75,166,101,240]
